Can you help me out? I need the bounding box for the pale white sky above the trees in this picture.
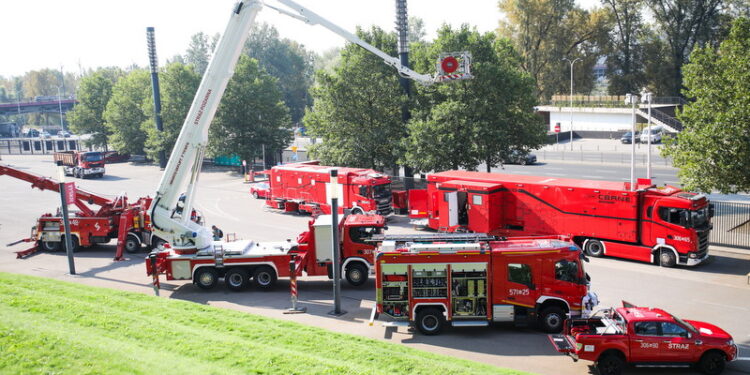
[0,0,596,77]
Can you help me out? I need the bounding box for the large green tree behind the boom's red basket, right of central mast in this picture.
[405,25,546,171]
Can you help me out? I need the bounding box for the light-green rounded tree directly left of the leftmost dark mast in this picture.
[104,69,152,155]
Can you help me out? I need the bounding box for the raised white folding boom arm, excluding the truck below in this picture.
[150,0,471,253]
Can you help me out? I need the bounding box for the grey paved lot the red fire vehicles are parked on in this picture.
[0,156,750,375]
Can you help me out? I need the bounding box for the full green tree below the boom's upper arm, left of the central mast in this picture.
[304,27,406,169]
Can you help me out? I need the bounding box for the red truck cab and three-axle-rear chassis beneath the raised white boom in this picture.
[146,215,385,291]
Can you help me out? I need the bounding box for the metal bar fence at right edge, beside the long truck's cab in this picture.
[709,201,750,250]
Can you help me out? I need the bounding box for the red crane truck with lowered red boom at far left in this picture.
[0,165,159,259]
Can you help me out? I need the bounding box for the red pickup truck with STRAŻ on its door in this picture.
[549,301,737,375]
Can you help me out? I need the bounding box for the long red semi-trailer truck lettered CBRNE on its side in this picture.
[409,171,713,267]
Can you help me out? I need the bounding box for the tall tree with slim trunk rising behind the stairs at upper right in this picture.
[647,0,725,96]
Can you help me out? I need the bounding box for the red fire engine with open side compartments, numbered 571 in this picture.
[373,236,598,335]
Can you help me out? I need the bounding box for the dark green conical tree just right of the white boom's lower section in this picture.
[209,55,292,161]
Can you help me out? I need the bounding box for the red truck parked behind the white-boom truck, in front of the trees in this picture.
[266,161,393,216]
